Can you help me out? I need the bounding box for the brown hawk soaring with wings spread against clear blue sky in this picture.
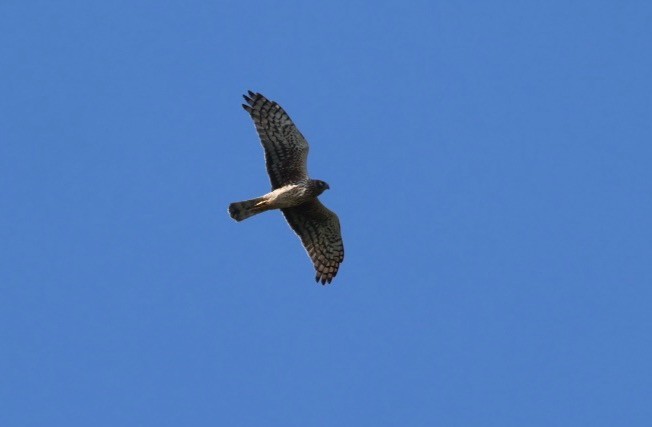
[229,91,344,285]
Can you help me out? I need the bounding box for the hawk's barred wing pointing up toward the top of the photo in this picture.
[242,91,308,190]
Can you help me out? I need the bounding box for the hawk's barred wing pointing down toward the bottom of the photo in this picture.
[282,199,344,285]
